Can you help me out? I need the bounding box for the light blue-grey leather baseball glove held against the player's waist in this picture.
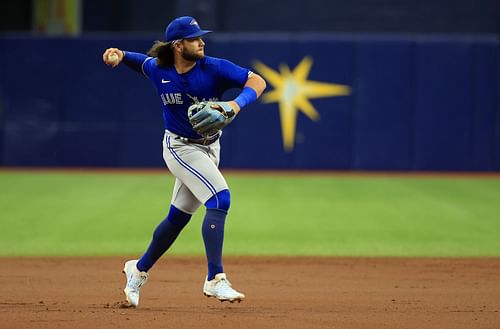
[188,102,236,137]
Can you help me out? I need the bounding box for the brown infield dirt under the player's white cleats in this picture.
[0,256,500,329]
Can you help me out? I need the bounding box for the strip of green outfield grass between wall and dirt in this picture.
[0,170,500,256]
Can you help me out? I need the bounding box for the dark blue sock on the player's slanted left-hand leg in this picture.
[137,205,191,272]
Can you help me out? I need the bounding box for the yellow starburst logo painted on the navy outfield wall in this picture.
[254,56,351,152]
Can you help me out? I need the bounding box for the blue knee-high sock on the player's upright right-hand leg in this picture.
[201,190,230,280]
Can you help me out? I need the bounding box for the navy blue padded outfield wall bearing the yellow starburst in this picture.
[0,34,500,171]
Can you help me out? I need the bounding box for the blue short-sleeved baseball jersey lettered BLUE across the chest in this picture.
[142,56,251,138]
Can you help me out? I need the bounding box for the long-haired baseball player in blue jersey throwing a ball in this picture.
[102,16,266,307]
